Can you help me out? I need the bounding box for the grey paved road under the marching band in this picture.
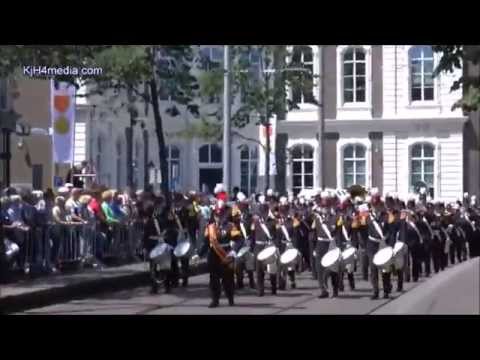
[15,259,480,315]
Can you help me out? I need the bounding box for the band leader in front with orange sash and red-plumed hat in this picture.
[192,200,235,308]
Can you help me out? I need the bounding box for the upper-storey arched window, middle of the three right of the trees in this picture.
[343,48,366,103]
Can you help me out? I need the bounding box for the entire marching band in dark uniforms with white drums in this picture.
[144,184,480,307]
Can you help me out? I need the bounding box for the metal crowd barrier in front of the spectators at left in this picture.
[0,221,143,274]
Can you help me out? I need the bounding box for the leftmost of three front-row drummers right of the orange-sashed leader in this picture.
[251,195,277,296]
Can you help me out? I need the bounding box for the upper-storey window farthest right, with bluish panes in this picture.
[409,46,434,101]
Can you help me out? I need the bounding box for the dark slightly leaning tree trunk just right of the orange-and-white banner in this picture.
[149,79,171,207]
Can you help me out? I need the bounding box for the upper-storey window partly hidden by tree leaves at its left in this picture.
[292,46,314,104]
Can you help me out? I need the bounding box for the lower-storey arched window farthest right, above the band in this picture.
[410,143,435,191]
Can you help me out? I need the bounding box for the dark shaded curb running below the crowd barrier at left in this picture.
[0,263,207,315]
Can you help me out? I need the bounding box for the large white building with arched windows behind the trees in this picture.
[76,45,466,200]
